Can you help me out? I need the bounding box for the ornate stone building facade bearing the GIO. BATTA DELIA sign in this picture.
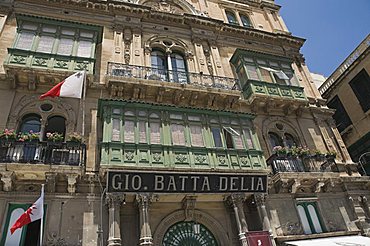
[0,0,370,246]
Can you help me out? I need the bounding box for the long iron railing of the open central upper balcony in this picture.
[107,62,239,90]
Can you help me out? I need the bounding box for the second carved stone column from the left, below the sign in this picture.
[136,194,153,245]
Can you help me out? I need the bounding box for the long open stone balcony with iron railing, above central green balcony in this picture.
[106,62,241,108]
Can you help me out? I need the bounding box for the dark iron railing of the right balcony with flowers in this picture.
[267,155,339,173]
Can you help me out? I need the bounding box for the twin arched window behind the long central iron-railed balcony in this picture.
[149,50,188,83]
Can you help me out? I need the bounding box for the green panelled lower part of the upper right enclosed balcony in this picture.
[243,79,307,101]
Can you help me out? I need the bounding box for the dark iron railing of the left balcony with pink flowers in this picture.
[0,141,86,166]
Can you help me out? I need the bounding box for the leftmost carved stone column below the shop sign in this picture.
[106,194,125,246]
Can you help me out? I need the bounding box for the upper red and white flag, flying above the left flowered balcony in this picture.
[40,71,85,99]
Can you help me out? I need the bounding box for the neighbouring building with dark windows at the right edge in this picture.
[319,35,370,173]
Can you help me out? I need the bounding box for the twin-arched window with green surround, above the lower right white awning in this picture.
[297,202,323,234]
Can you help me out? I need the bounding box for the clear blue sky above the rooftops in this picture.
[275,0,370,76]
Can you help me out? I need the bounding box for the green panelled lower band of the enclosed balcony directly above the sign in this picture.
[100,142,266,170]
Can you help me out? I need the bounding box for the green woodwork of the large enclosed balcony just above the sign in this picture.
[98,100,266,169]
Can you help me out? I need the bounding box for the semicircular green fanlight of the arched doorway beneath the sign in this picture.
[162,222,218,246]
